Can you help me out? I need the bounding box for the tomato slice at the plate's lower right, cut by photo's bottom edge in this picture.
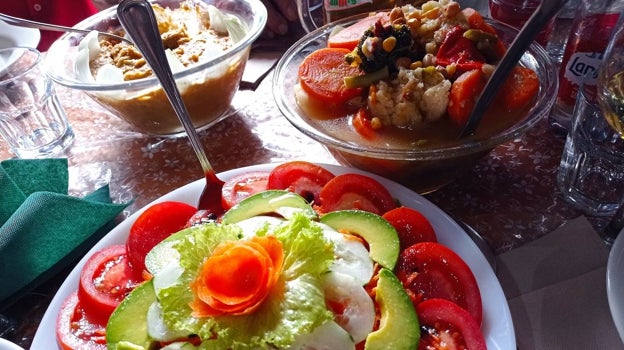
[416,299,487,350]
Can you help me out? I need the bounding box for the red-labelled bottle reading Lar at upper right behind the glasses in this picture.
[549,0,624,133]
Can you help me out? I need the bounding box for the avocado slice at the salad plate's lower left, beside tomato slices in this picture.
[106,280,156,350]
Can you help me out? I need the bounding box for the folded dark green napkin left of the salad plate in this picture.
[0,159,130,309]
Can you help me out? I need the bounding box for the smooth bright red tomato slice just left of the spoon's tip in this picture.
[126,201,197,276]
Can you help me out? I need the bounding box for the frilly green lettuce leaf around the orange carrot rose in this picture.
[158,214,334,349]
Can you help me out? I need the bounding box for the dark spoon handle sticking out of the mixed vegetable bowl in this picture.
[460,0,568,137]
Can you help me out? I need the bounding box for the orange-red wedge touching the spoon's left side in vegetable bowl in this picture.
[447,69,486,126]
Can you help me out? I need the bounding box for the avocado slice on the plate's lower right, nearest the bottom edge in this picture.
[364,268,420,350]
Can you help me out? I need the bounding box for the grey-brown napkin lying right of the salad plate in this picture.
[496,217,624,350]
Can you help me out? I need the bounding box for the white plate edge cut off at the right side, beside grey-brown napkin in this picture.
[607,229,624,341]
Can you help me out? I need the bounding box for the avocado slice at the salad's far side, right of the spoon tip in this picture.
[221,190,317,224]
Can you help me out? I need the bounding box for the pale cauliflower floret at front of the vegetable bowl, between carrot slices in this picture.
[368,67,451,127]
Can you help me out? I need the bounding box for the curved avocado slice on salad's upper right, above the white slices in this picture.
[321,210,400,270]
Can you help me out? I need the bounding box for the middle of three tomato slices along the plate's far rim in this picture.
[267,161,335,203]
